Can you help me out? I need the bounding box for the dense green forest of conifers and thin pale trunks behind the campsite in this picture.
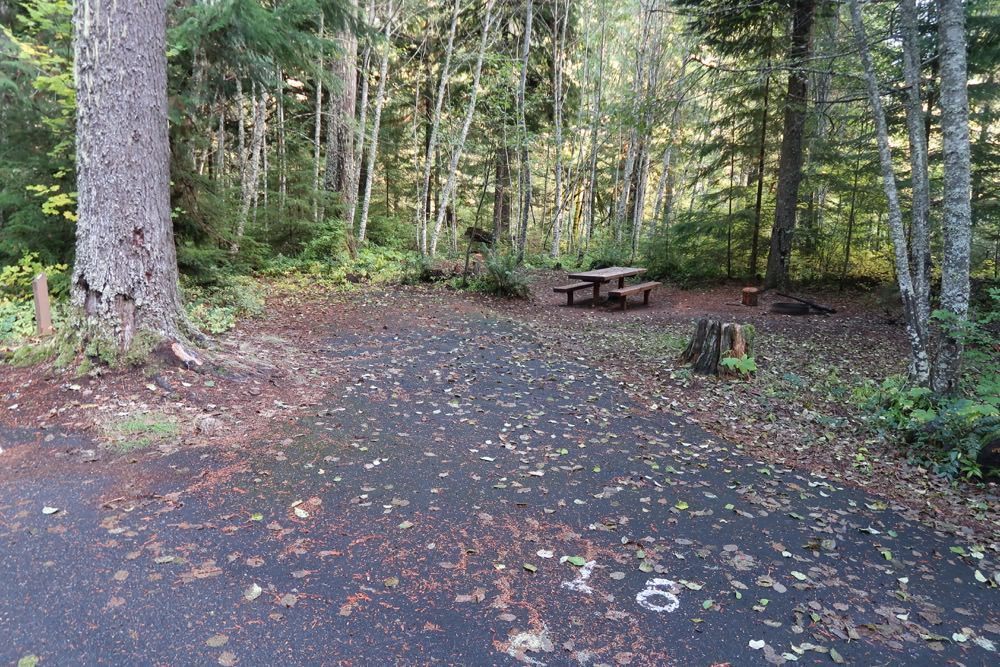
[0,0,1000,336]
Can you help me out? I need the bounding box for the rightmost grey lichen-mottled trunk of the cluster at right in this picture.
[932,0,972,392]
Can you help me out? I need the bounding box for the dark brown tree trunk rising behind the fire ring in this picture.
[764,0,816,287]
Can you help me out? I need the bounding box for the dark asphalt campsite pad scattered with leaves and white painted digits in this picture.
[0,316,1000,665]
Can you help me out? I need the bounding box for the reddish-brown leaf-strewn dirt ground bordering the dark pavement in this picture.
[0,271,1000,544]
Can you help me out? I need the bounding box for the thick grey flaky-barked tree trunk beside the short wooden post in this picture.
[72,0,184,350]
